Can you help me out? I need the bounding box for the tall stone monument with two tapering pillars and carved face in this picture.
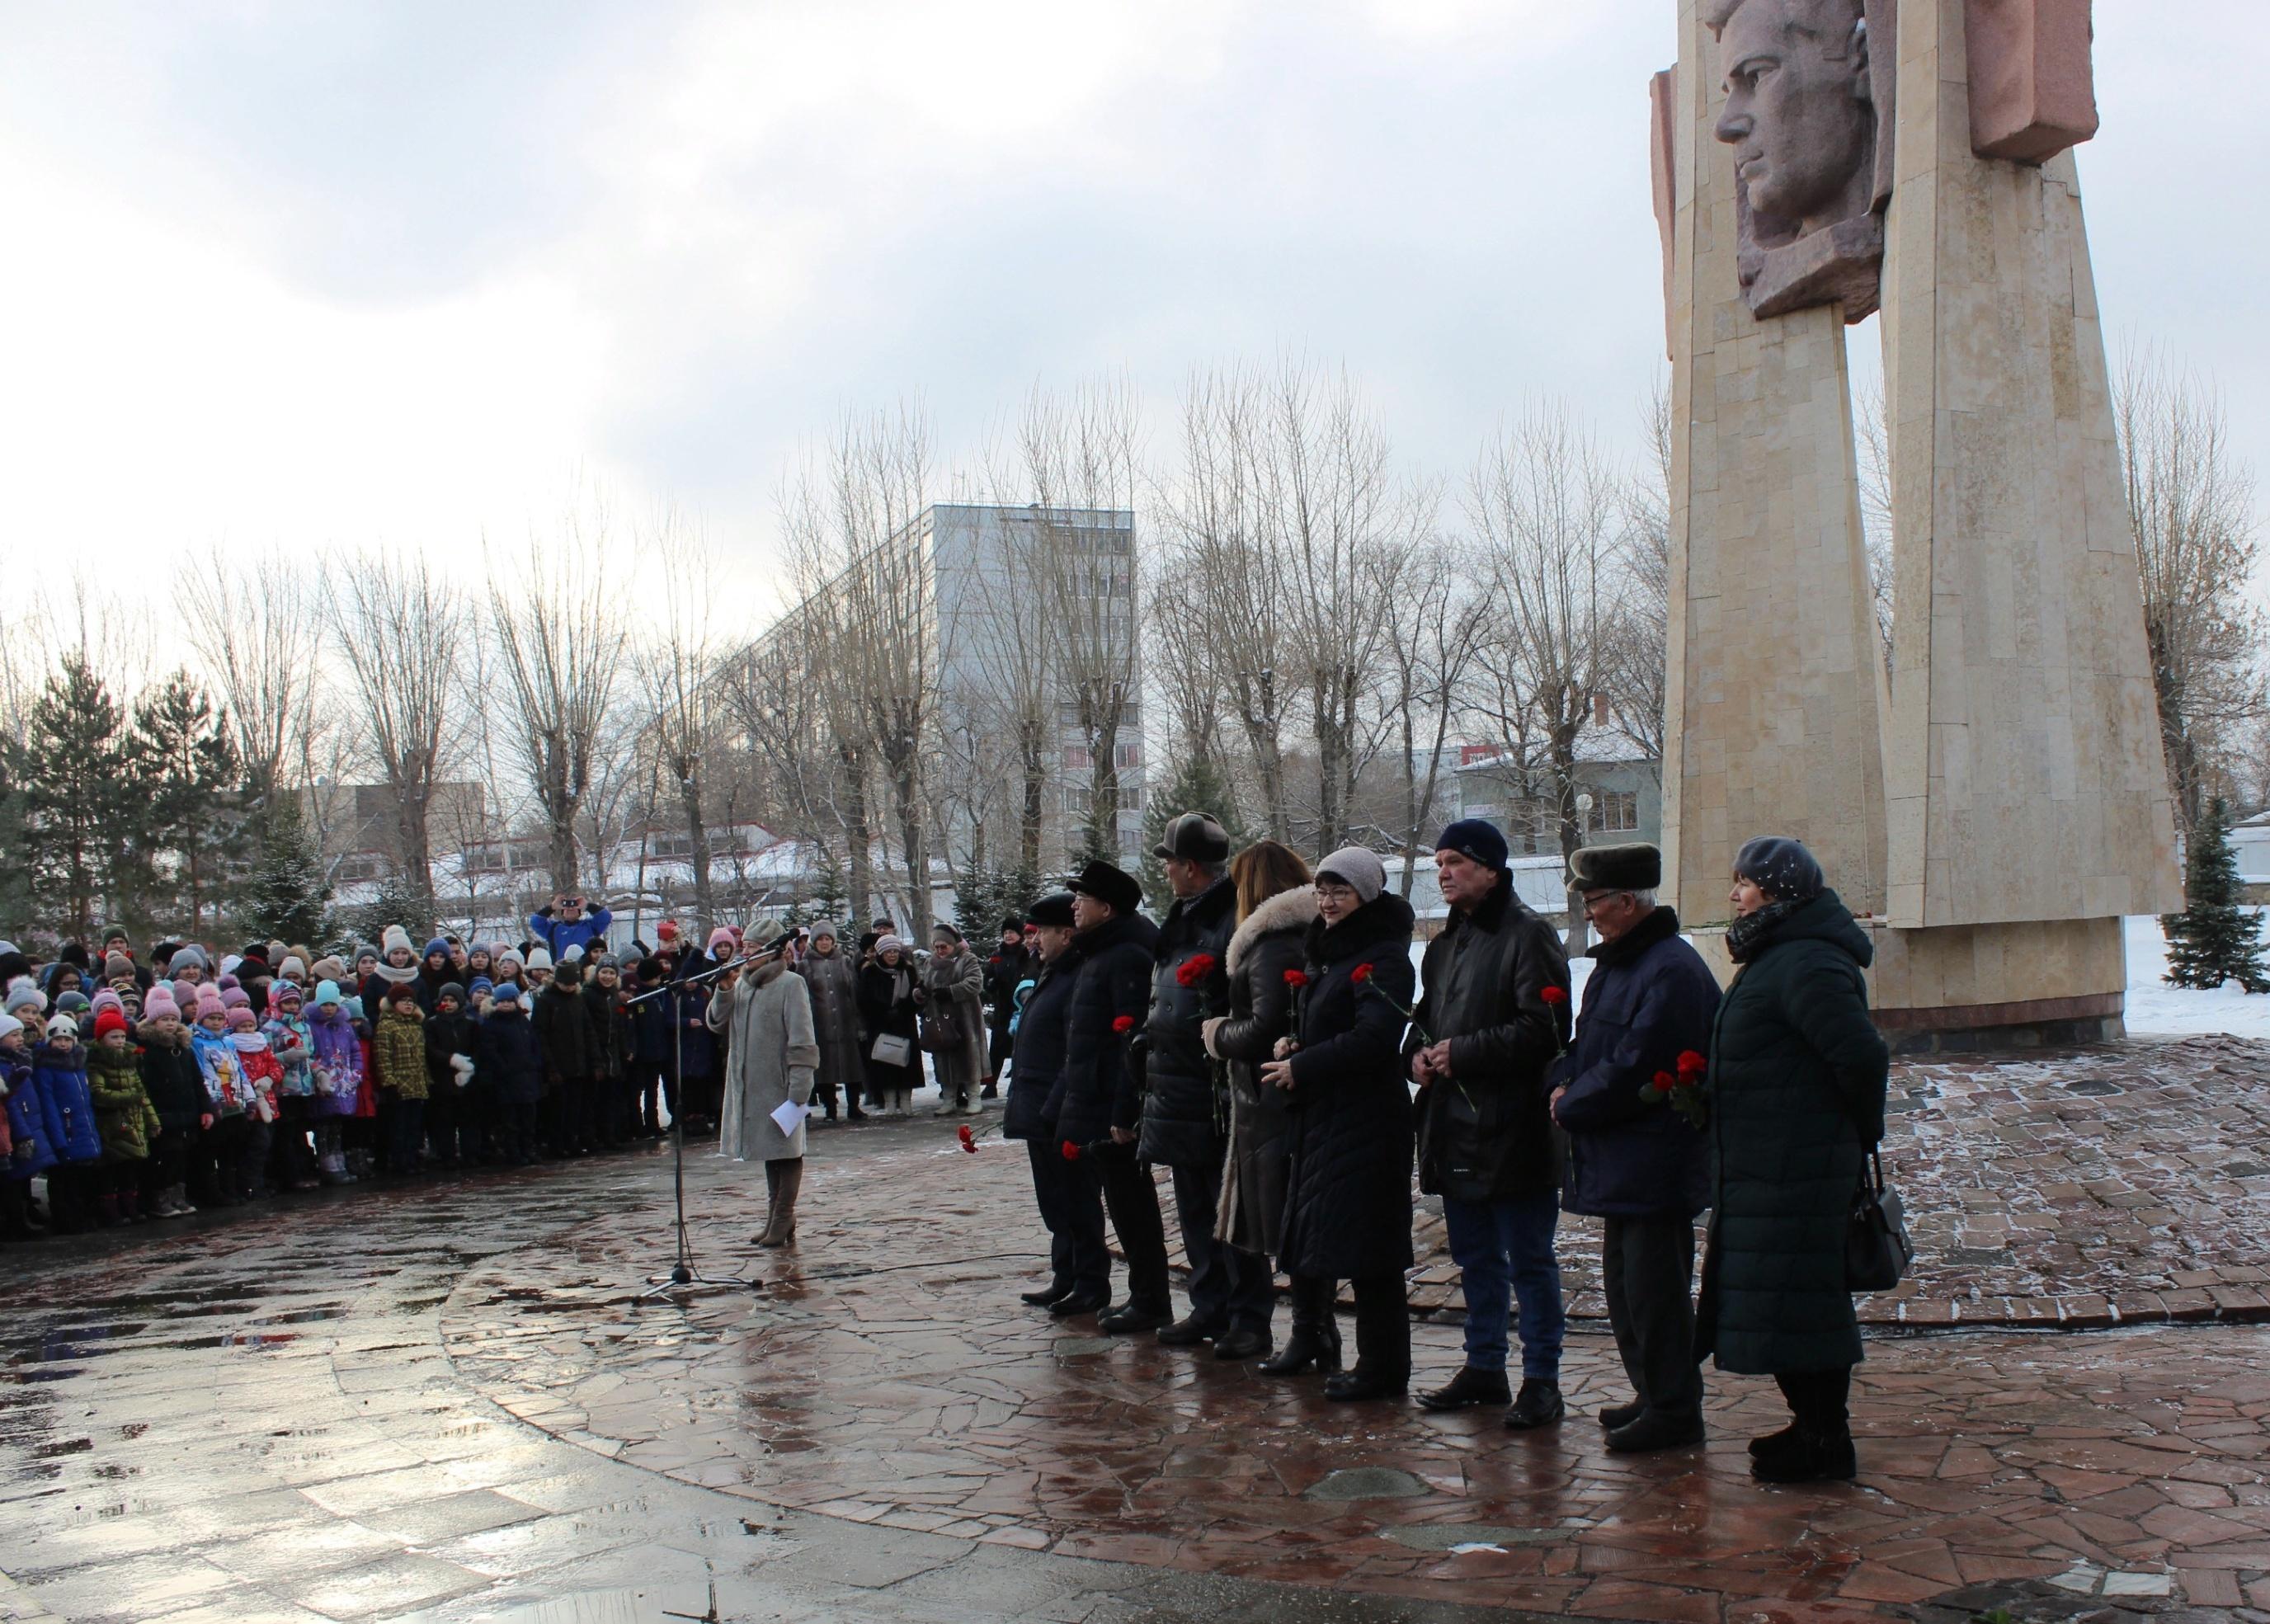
[1651,0,2182,1047]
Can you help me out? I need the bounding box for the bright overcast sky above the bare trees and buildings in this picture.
[0,0,2270,636]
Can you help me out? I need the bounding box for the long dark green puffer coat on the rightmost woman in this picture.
[1696,891,1891,1377]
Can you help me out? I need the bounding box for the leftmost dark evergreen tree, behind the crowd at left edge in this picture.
[9,652,139,940]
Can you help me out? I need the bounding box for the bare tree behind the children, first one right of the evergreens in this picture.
[325,554,472,897]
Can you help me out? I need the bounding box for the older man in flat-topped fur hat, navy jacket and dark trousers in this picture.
[1552,845,1718,1453]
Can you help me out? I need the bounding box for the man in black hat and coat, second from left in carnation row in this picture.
[1047,861,1169,1335]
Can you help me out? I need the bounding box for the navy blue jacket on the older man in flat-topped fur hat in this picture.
[1546,909,1718,1217]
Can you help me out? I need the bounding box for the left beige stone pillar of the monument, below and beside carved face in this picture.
[1664,0,1884,925]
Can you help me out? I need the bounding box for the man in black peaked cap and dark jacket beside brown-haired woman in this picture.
[1137,813,1276,1361]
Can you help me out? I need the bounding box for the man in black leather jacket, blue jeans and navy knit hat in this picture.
[1407,817,1569,1431]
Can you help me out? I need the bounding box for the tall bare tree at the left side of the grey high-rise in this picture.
[785,404,940,936]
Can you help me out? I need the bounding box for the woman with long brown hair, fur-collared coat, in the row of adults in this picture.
[1205,840,1340,1377]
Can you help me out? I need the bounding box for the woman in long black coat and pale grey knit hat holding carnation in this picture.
[1262,847,1416,1401]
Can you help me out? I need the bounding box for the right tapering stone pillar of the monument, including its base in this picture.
[1877,0,2182,1036]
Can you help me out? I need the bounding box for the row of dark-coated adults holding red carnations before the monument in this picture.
[1005,813,1889,1483]
